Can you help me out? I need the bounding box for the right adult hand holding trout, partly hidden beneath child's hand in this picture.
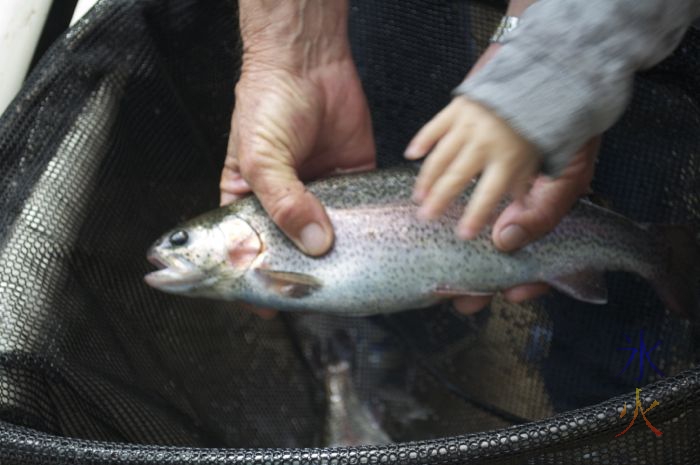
[453,137,600,314]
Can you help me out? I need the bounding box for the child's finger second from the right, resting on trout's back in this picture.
[419,146,483,223]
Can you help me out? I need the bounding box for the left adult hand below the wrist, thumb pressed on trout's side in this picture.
[220,58,375,255]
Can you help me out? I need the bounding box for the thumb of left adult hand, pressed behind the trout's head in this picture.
[241,156,333,256]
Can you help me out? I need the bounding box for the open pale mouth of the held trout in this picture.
[144,248,206,292]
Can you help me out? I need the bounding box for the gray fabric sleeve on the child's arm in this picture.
[455,0,700,175]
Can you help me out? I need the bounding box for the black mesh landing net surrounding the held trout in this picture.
[0,0,700,465]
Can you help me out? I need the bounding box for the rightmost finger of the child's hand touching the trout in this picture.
[457,163,516,239]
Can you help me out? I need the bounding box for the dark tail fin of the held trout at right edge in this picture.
[649,225,700,324]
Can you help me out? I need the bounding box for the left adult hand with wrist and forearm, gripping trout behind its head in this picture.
[220,0,376,255]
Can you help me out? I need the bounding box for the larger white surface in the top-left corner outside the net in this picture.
[0,0,51,113]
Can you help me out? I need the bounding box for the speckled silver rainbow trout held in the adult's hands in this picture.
[145,166,700,316]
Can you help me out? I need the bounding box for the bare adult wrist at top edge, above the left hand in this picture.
[239,0,350,71]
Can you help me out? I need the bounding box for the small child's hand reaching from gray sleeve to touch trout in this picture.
[405,97,540,239]
